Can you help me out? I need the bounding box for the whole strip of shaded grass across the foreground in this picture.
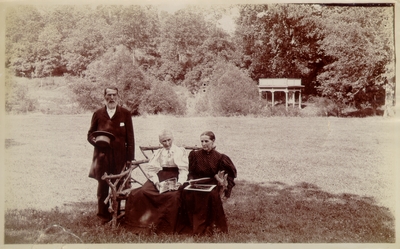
[5,181,395,244]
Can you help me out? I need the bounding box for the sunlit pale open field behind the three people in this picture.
[4,114,400,243]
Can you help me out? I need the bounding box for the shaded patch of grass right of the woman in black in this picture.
[225,182,395,243]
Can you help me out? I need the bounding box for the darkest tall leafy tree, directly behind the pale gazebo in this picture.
[237,4,322,93]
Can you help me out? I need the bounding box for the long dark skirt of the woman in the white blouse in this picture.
[125,168,181,233]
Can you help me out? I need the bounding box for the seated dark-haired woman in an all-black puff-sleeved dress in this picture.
[179,131,236,235]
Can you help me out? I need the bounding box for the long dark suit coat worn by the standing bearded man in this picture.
[87,106,135,180]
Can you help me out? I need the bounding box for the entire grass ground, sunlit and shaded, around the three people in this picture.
[3,114,400,244]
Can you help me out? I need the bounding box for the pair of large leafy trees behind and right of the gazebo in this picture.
[236,4,394,114]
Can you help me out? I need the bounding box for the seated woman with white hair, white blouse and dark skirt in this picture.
[125,130,188,233]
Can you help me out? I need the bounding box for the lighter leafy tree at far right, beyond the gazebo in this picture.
[317,7,394,112]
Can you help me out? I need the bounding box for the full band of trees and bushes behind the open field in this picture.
[6,4,395,114]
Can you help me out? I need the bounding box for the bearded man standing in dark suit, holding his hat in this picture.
[87,87,135,221]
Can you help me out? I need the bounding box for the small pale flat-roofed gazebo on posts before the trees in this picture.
[258,78,304,109]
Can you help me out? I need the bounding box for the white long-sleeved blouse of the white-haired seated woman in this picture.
[147,144,189,184]
